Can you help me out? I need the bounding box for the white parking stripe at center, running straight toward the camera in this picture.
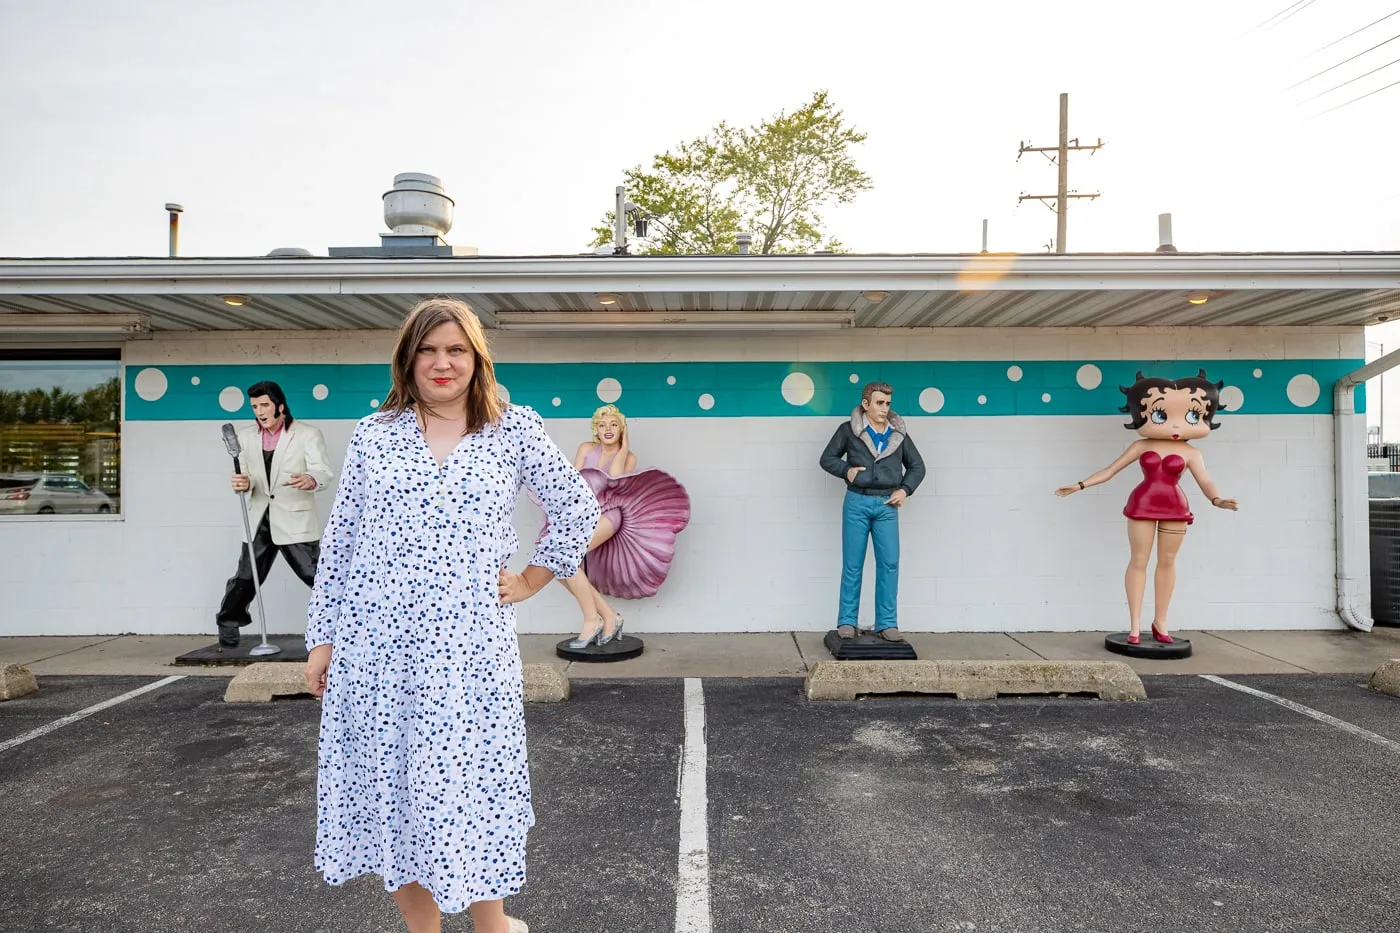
[676,677,710,933]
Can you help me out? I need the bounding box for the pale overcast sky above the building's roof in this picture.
[0,0,1400,256]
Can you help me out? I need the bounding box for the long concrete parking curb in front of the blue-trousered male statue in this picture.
[805,652,1147,700]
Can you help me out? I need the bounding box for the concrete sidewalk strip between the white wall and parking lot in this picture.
[0,628,1400,679]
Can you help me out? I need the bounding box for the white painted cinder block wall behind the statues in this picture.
[0,328,1365,635]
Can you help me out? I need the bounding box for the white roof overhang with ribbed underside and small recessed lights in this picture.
[0,252,1400,332]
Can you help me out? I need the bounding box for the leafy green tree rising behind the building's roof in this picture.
[592,91,872,255]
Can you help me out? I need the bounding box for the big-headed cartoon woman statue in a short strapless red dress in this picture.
[1054,370,1239,644]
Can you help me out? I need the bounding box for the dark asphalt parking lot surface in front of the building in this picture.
[0,675,1400,933]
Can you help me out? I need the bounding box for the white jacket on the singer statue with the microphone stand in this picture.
[238,420,335,545]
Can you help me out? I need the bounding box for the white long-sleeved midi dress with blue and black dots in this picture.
[307,406,598,913]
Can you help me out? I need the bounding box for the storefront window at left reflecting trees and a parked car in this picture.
[0,350,122,518]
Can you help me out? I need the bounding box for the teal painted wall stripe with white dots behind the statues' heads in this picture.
[126,360,1365,422]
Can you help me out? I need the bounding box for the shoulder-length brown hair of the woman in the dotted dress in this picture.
[379,298,503,434]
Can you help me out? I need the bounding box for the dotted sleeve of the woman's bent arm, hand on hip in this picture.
[521,408,602,579]
